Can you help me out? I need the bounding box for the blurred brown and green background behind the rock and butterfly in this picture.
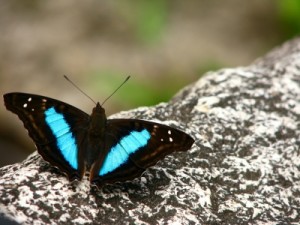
[0,0,300,167]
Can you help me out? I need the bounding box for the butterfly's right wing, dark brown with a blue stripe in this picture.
[91,119,194,186]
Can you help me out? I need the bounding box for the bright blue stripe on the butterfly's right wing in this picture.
[99,129,151,176]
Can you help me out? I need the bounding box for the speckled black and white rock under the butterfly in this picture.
[0,39,300,224]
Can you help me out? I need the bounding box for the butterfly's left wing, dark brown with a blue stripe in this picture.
[4,93,89,180]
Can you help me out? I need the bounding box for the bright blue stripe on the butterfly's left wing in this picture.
[45,107,78,169]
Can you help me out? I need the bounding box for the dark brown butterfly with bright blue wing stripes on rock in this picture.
[4,90,194,187]
